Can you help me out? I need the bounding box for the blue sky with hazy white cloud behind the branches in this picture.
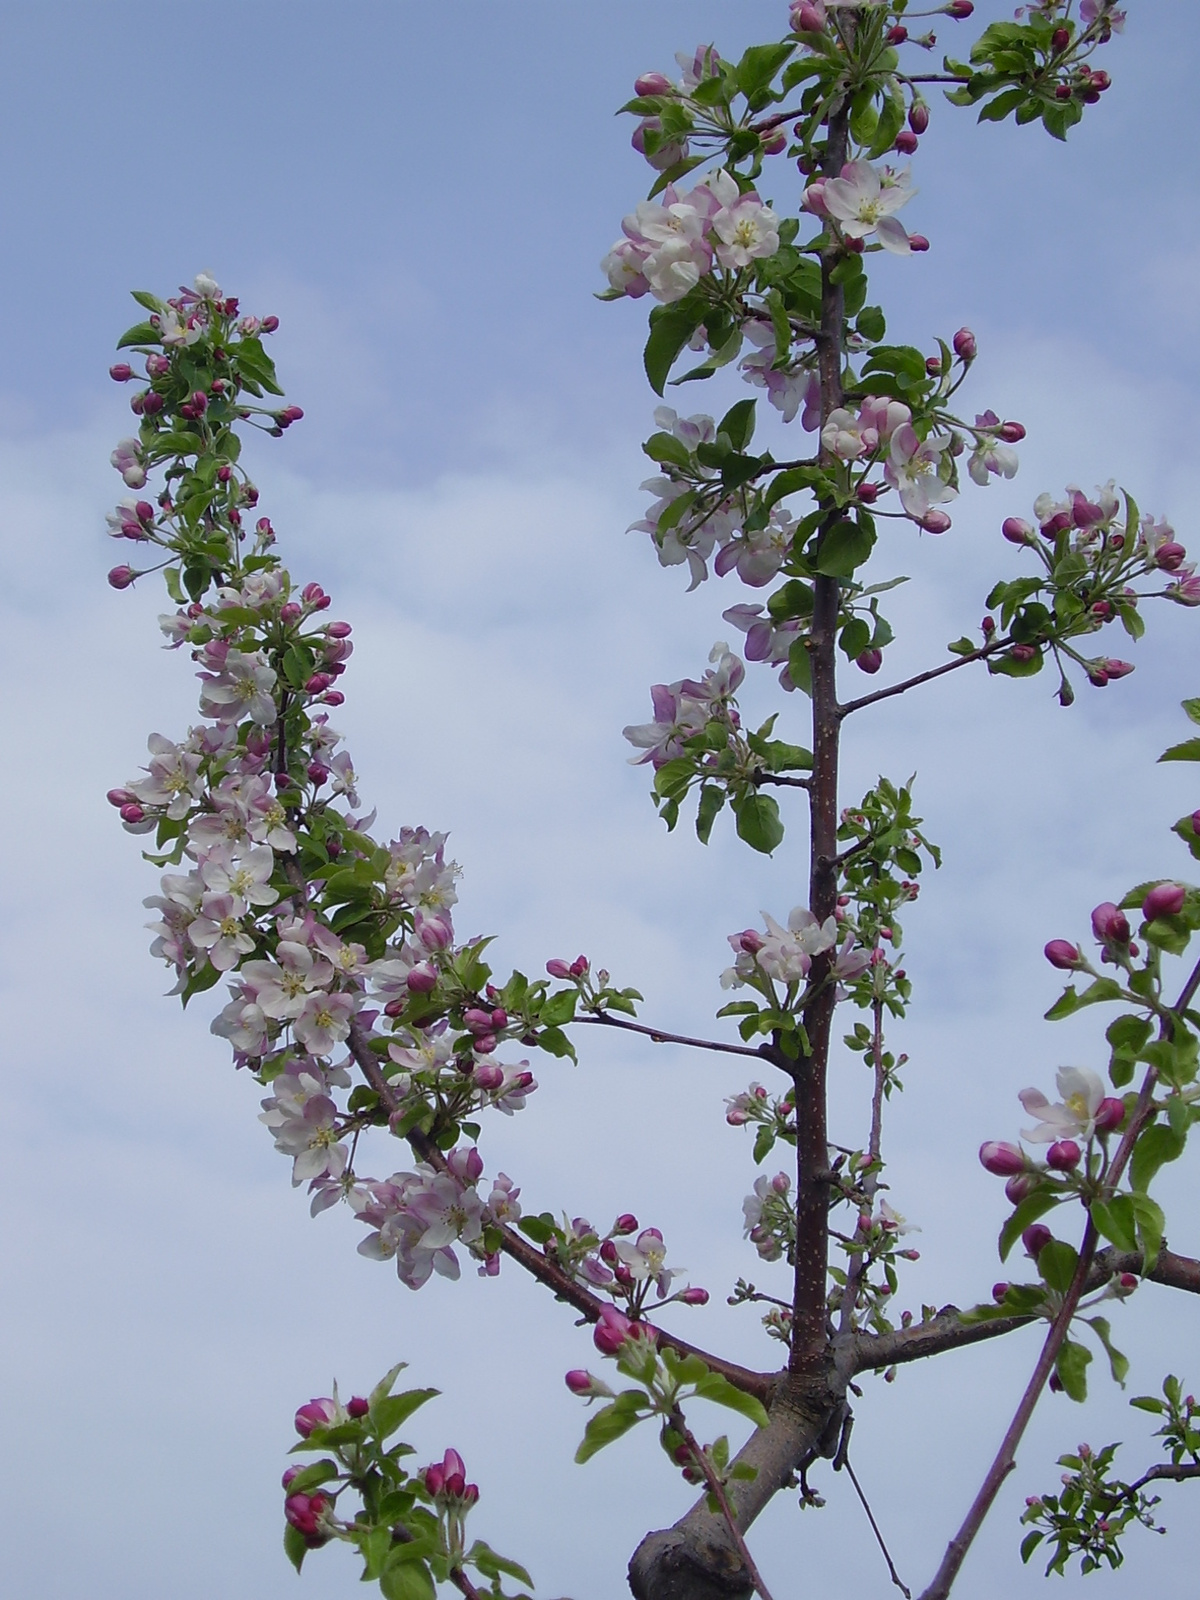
[0,0,1200,1600]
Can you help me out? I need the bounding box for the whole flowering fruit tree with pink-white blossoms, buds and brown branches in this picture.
[101,0,1200,1600]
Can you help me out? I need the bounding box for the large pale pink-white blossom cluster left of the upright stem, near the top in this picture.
[602,163,779,304]
